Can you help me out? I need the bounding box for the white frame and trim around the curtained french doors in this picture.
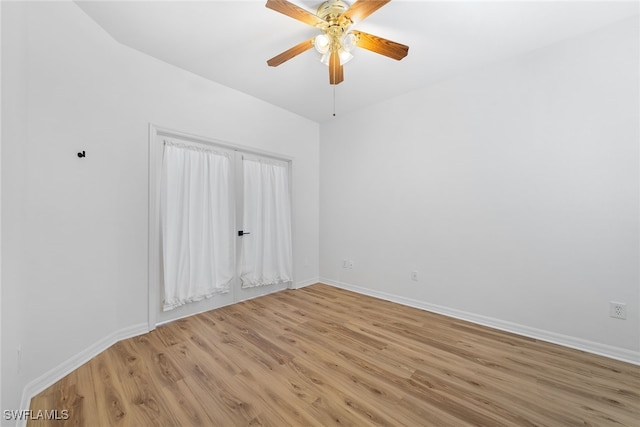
[147,123,296,331]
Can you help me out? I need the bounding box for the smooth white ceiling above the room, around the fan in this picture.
[76,0,639,122]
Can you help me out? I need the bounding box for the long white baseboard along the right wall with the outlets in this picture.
[319,277,640,365]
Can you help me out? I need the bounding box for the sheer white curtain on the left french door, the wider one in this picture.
[161,141,234,311]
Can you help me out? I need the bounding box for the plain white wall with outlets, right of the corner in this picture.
[320,18,640,362]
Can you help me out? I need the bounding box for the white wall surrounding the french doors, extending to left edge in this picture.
[2,2,319,409]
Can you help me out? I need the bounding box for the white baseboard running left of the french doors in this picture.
[17,323,149,427]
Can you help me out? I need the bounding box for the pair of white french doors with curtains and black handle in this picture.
[149,126,293,329]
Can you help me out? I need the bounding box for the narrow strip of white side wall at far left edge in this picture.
[0,2,27,425]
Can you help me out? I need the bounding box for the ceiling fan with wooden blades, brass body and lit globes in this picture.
[266,0,409,85]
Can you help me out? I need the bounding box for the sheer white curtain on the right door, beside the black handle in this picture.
[240,158,292,288]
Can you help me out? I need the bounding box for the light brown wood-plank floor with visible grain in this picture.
[29,284,640,427]
